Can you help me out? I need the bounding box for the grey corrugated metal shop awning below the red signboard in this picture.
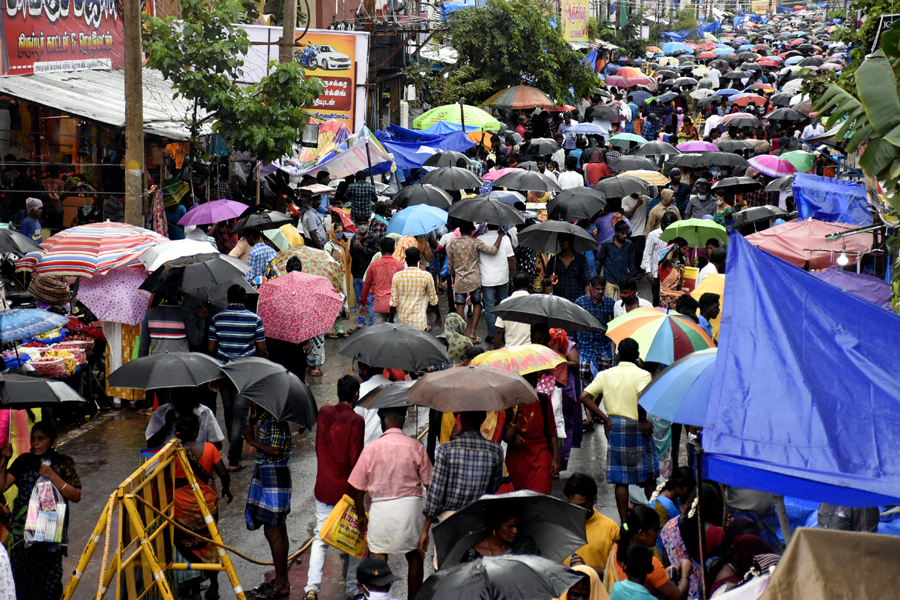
[0,68,210,140]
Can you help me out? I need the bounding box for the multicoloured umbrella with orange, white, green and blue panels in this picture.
[606,308,716,365]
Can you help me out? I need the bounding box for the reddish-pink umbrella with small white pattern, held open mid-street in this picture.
[256,271,344,344]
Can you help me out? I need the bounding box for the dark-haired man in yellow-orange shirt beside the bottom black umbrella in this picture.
[563,473,619,579]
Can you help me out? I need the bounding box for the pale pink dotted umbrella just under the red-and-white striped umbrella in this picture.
[78,268,150,325]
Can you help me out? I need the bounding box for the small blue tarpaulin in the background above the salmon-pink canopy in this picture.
[792,173,872,225]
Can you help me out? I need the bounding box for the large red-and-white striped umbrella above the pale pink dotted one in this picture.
[16,222,169,277]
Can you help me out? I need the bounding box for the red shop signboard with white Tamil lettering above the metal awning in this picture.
[0,0,156,75]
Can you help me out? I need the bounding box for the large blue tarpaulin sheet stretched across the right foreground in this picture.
[703,232,900,506]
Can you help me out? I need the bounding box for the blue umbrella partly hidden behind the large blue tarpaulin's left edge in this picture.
[638,348,716,427]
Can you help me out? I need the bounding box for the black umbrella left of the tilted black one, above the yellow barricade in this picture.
[107,352,222,390]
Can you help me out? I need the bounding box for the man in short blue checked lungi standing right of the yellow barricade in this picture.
[243,404,292,599]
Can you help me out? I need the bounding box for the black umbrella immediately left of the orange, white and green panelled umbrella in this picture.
[490,294,606,331]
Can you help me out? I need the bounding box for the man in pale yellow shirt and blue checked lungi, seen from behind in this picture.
[581,338,659,523]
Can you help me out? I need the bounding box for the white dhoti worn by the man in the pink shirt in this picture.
[368,496,425,554]
